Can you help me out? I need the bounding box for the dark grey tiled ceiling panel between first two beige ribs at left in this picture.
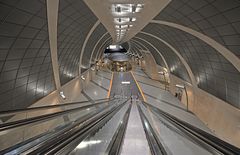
[58,0,97,85]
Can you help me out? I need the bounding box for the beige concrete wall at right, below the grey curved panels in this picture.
[170,74,240,147]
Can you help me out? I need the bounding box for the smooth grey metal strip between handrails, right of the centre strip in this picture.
[141,105,216,155]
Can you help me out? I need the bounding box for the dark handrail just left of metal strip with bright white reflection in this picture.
[28,100,128,155]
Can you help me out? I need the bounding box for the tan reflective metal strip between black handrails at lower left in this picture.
[0,99,110,154]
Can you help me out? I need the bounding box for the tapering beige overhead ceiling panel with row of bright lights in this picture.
[85,0,170,43]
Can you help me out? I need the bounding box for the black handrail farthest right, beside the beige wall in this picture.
[142,102,240,155]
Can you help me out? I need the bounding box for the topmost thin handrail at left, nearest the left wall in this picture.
[0,98,113,117]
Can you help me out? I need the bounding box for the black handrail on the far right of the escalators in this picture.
[143,102,240,155]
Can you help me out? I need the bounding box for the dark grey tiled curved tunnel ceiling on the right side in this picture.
[130,0,240,107]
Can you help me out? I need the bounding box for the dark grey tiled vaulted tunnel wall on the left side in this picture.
[0,0,111,111]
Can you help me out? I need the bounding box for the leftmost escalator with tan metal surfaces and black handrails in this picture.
[0,99,127,154]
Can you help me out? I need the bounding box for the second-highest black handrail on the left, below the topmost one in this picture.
[0,101,113,131]
